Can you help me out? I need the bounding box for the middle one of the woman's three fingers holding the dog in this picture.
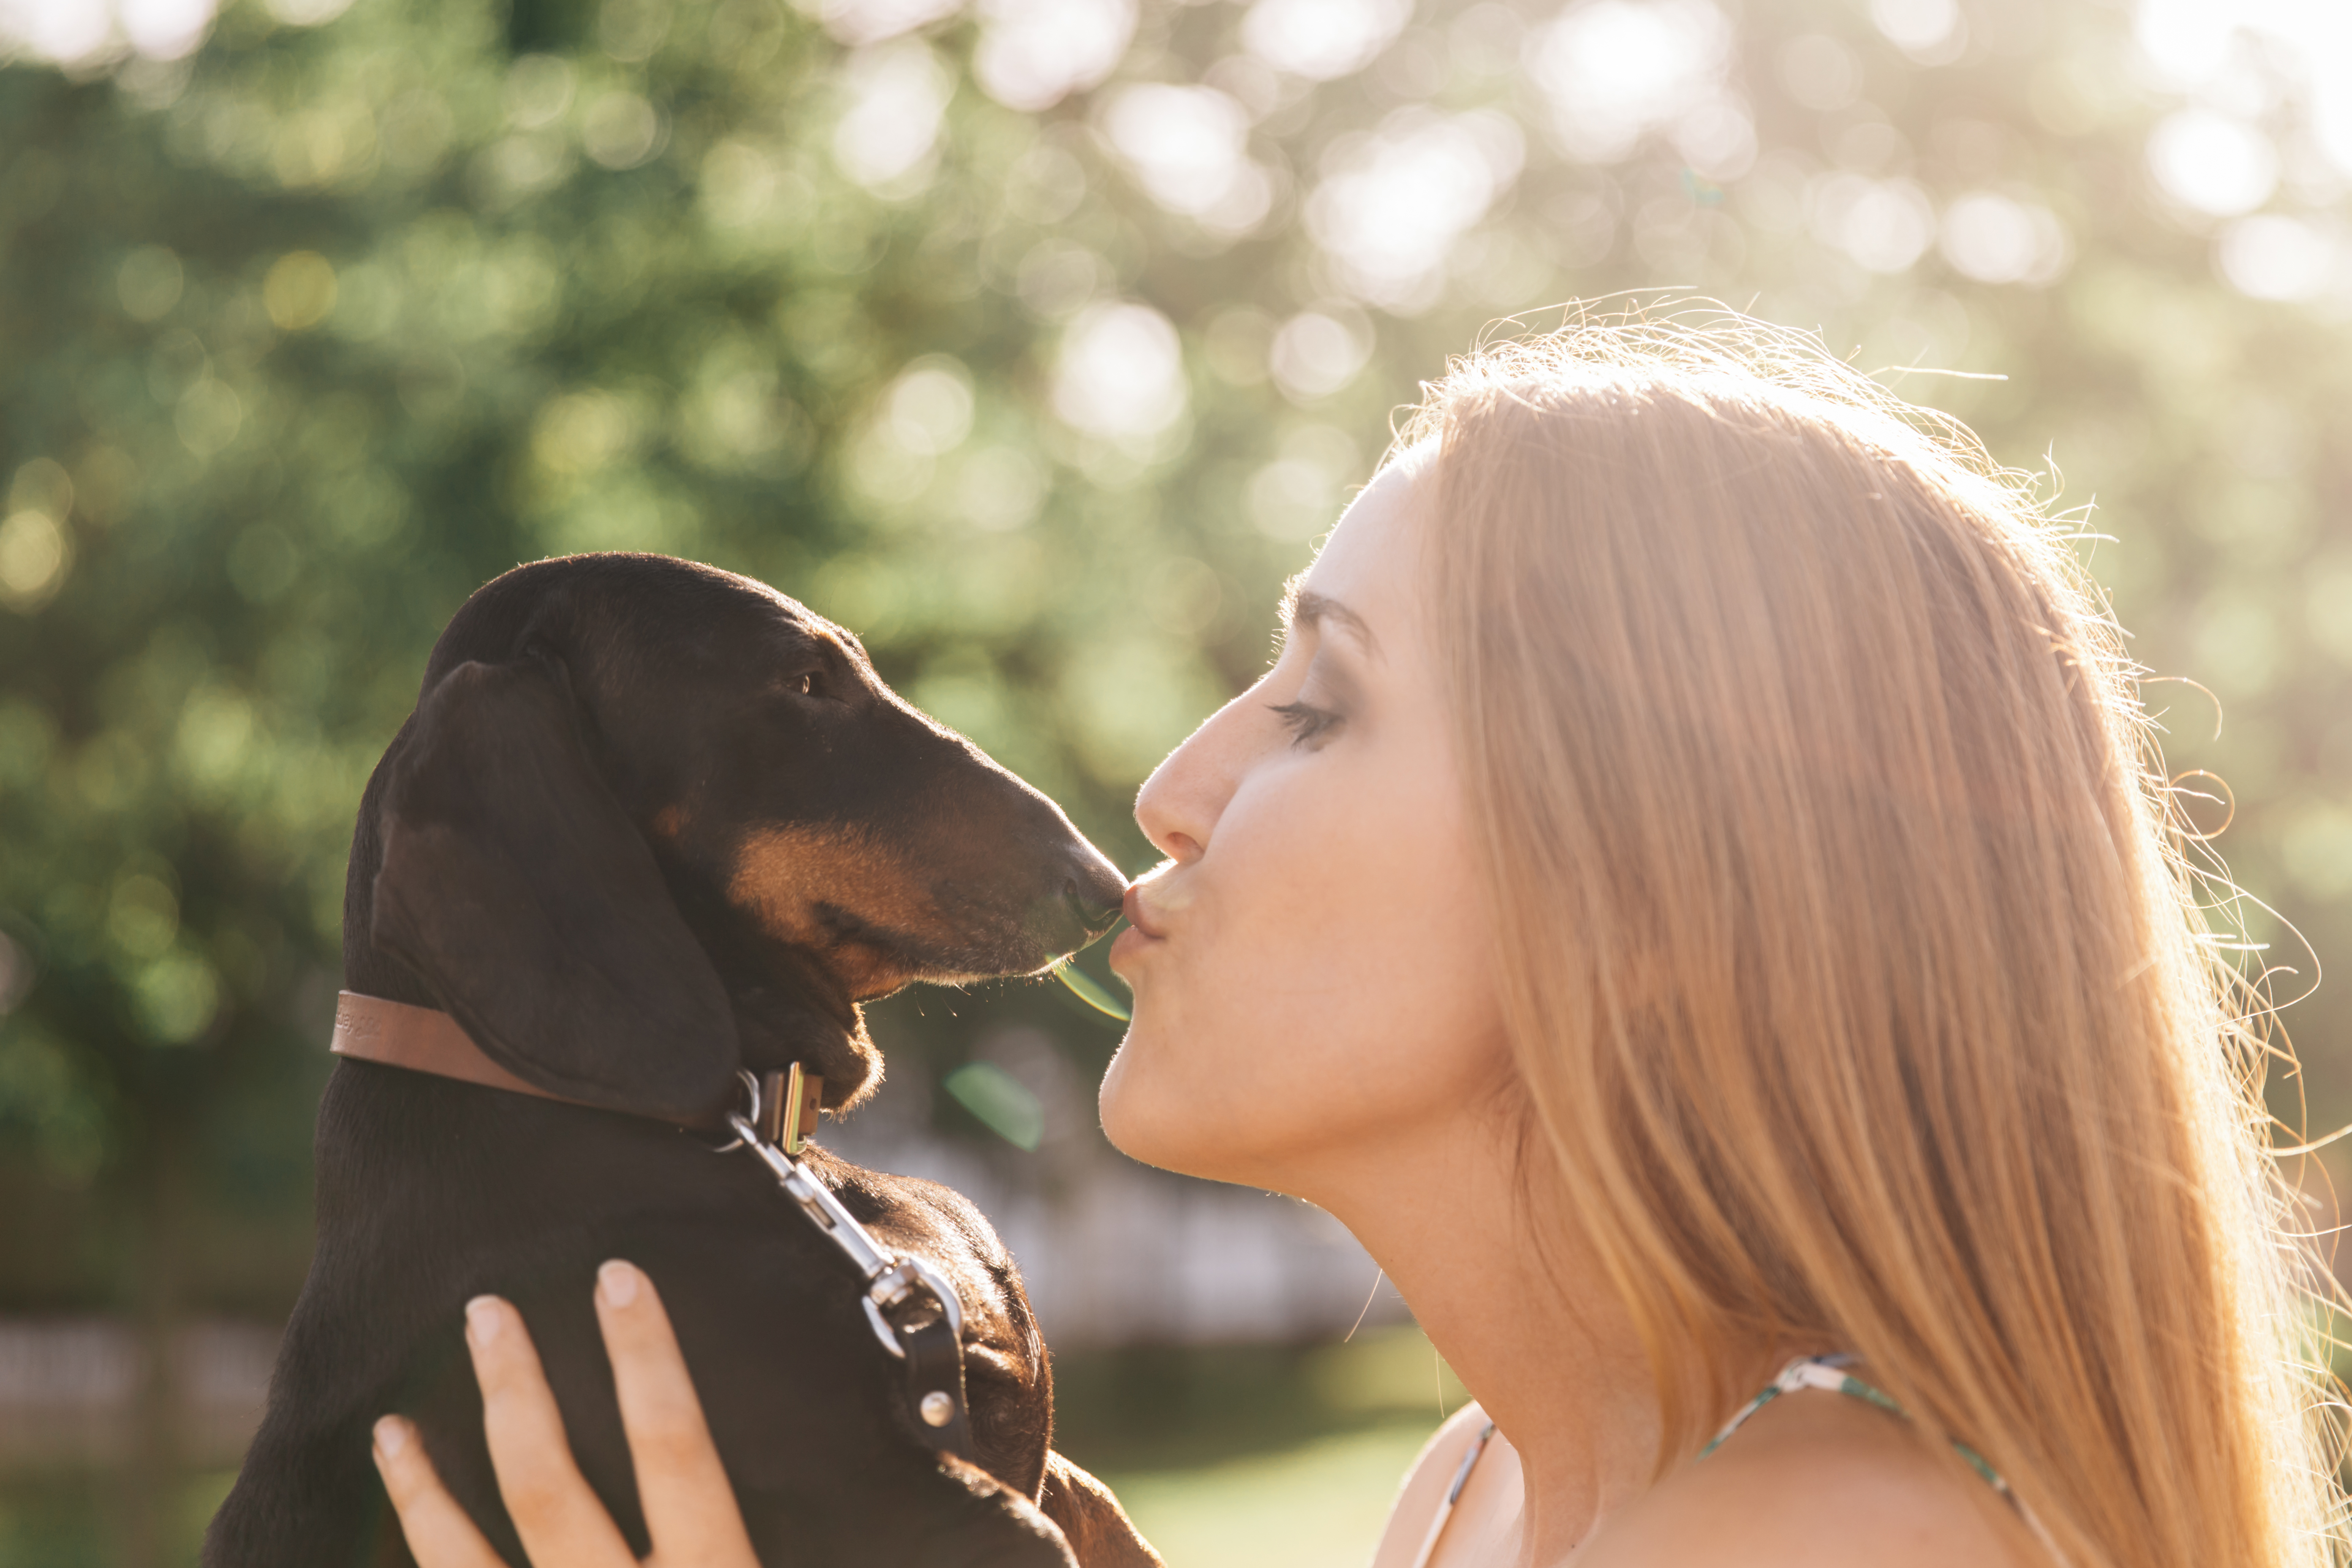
[466,1295,637,1568]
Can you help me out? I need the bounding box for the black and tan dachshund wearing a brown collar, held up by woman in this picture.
[202,555,1160,1568]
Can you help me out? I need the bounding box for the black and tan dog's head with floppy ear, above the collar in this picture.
[346,555,1124,1121]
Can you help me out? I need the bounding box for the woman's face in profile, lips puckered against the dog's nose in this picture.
[1103,459,1505,1199]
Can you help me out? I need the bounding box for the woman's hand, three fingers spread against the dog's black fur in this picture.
[376,1260,760,1568]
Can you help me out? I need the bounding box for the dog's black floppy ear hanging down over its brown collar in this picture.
[374,658,739,1121]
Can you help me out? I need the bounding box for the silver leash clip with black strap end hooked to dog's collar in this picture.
[720,1072,979,1465]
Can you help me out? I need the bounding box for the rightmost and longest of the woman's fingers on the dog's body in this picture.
[595,1258,757,1568]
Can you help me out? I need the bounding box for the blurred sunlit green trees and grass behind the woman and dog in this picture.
[0,0,2352,1568]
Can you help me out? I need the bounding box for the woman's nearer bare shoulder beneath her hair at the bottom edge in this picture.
[1576,1394,2039,1568]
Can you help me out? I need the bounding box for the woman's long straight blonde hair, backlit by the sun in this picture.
[1400,313,2340,1568]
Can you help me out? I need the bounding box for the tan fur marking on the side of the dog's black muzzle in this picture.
[727,827,941,997]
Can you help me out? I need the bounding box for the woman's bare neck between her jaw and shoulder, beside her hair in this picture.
[1286,1109,1661,1568]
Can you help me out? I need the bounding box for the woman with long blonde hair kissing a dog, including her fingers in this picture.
[379,318,2343,1568]
